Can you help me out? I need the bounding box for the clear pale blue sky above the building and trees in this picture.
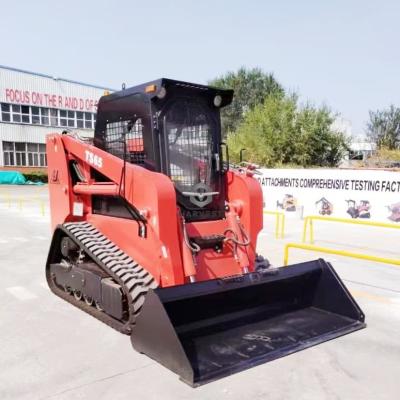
[0,0,400,134]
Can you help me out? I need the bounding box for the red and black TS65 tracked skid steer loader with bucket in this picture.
[46,79,365,386]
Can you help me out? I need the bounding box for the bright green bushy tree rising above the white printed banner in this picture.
[228,93,348,167]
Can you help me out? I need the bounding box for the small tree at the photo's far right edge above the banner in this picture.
[367,105,400,150]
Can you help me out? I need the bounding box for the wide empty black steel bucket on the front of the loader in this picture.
[131,260,366,386]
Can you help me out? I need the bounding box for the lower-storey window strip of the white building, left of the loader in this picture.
[3,142,47,167]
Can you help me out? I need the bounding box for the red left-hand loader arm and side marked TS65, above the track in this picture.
[47,135,184,286]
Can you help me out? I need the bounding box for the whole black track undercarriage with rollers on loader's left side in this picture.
[46,222,157,334]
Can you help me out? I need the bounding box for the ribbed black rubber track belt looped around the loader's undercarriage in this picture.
[47,222,157,334]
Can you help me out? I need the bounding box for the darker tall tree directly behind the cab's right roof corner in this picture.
[209,67,284,135]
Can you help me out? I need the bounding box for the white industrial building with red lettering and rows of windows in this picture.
[0,65,112,171]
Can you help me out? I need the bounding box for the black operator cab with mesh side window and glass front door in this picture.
[95,79,233,221]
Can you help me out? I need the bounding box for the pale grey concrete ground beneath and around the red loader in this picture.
[0,186,400,400]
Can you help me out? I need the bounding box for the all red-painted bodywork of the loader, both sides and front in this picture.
[47,134,262,287]
